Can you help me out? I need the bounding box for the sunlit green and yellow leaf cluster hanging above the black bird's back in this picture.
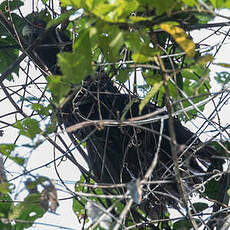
[54,0,216,118]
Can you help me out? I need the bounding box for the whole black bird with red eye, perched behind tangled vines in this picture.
[23,13,223,218]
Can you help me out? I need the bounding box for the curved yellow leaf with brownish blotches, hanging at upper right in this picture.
[160,23,195,57]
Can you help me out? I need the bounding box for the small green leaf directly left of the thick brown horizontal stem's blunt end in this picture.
[14,117,41,139]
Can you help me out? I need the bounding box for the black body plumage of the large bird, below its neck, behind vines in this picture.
[62,74,220,183]
